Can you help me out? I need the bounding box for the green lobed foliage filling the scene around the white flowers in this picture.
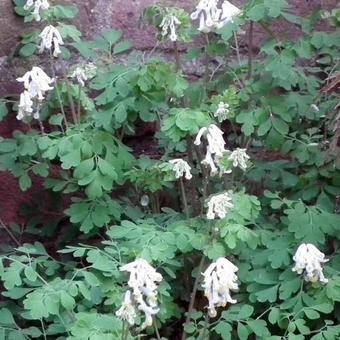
[0,0,340,340]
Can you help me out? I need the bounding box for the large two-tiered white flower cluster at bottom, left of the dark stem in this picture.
[116,259,163,329]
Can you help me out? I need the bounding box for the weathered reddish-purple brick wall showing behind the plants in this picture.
[0,0,338,228]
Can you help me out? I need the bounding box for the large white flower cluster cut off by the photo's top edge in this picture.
[191,0,241,33]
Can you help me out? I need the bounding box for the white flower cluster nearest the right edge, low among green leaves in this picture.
[292,243,328,283]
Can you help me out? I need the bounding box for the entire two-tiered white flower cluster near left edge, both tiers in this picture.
[17,66,54,120]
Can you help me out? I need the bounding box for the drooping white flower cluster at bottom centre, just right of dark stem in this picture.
[202,257,238,318]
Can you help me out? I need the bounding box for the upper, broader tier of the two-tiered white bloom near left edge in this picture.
[17,66,54,100]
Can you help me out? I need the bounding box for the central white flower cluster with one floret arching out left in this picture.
[194,124,226,176]
